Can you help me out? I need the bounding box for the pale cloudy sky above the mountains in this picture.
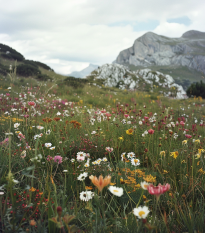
[0,0,205,74]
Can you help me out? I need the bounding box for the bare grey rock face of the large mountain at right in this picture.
[115,30,205,74]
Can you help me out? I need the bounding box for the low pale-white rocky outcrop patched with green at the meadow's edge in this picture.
[87,64,186,98]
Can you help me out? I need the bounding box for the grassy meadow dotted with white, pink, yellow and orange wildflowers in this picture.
[0,68,205,233]
